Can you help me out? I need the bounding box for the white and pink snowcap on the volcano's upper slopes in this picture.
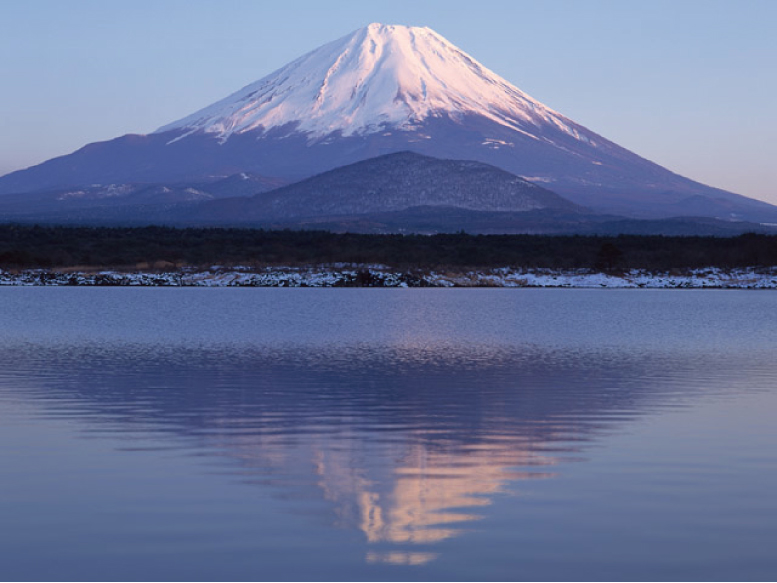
[156,23,577,140]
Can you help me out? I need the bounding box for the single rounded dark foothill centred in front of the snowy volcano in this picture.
[182,152,582,224]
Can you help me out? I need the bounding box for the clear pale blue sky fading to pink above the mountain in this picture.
[0,0,777,204]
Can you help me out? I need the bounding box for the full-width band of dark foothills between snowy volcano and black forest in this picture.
[10,152,775,236]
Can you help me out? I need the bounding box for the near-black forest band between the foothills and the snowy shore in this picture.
[0,225,777,271]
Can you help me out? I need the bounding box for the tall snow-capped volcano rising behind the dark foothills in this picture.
[0,24,777,222]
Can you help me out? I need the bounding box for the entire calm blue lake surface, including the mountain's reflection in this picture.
[0,288,777,580]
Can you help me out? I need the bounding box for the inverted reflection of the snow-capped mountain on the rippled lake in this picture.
[0,342,742,565]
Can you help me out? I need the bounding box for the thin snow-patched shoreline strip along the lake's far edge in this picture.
[0,265,777,289]
